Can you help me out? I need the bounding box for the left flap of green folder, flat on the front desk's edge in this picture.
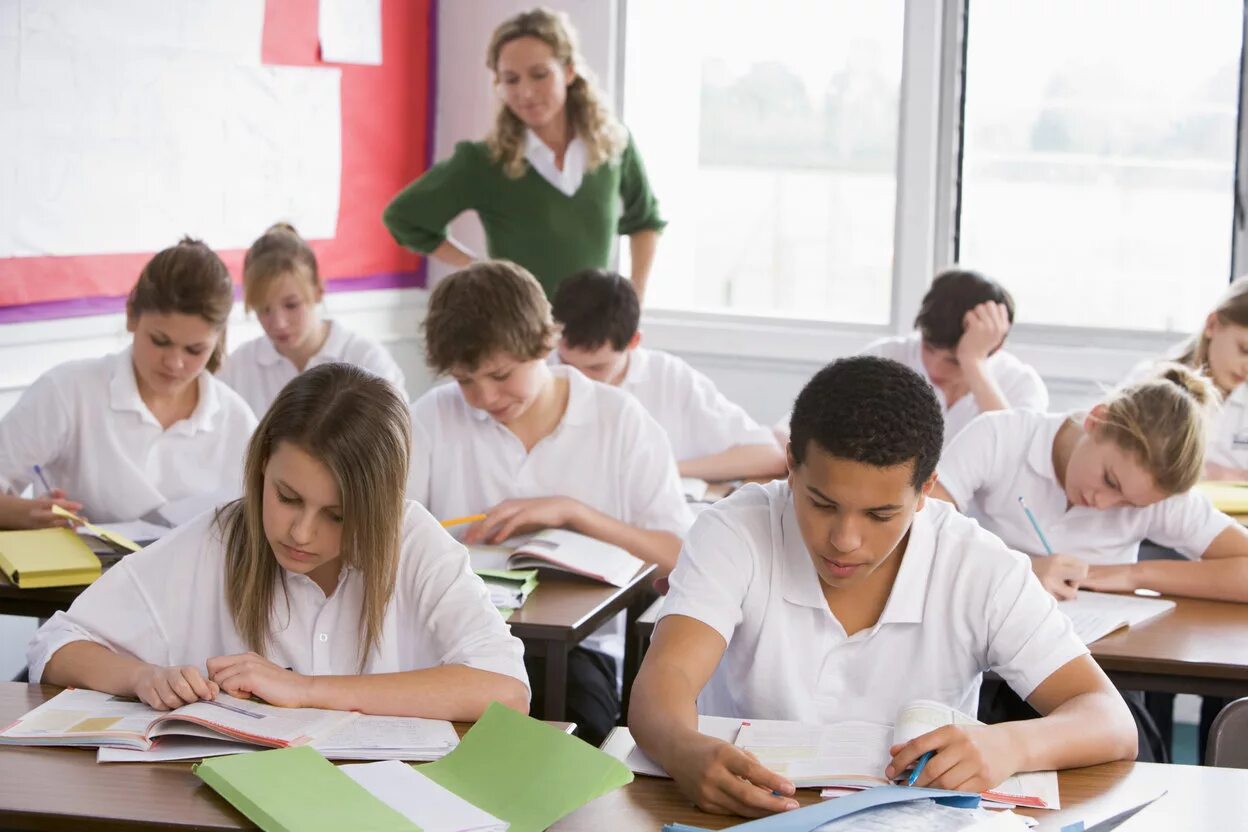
[191,746,421,832]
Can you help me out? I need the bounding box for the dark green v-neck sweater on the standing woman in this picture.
[383,137,666,296]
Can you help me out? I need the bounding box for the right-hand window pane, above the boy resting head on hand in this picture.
[958,0,1243,331]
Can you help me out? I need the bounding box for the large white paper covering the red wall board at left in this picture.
[0,0,342,257]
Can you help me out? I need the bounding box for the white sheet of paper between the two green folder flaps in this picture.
[338,760,509,832]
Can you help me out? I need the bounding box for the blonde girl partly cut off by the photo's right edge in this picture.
[1127,277,1248,480]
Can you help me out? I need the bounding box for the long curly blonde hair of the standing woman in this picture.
[485,6,628,180]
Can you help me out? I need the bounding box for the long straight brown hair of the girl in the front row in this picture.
[217,364,412,671]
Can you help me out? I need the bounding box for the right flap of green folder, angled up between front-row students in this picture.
[417,702,633,832]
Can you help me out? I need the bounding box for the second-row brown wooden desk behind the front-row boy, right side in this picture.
[629,597,1248,699]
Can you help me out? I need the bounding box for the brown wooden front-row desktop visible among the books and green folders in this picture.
[0,682,1248,832]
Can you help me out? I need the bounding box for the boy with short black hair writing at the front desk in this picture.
[629,357,1136,815]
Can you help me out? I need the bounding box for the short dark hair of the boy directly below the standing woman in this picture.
[552,268,641,352]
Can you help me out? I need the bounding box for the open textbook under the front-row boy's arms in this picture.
[603,700,1061,808]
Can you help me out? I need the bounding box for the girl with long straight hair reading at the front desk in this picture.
[29,364,529,720]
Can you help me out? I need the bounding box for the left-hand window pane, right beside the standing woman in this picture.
[622,0,904,323]
